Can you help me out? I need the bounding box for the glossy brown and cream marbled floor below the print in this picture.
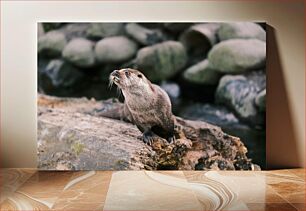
[0,169,306,211]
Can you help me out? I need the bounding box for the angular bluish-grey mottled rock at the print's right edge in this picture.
[216,72,266,125]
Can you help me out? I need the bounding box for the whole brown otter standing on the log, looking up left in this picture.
[110,68,176,145]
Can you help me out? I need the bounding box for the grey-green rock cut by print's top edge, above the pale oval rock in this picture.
[86,23,124,40]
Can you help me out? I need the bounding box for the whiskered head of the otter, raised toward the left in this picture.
[110,68,153,93]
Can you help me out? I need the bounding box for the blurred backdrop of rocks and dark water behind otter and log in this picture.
[37,22,266,169]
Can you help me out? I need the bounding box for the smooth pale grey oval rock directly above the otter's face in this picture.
[95,36,138,63]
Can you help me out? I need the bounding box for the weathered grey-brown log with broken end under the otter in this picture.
[38,95,258,170]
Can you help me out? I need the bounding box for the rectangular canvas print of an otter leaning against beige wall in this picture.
[37,22,266,170]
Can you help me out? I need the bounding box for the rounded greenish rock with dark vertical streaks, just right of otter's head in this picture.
[135,41,187,81]
